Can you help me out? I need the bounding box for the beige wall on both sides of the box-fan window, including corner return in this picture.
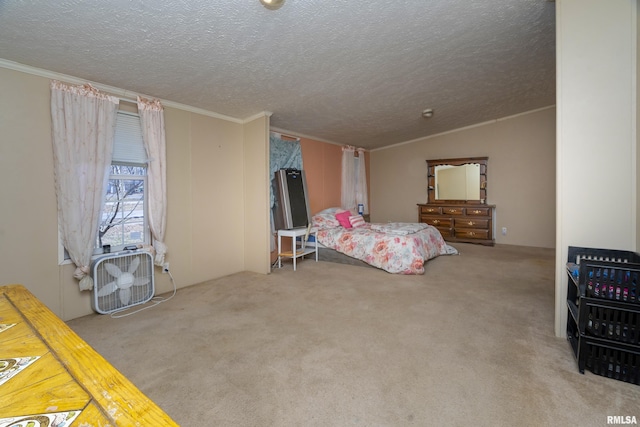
[0,67,268,320]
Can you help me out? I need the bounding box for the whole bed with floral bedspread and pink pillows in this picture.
[312,208,457,274]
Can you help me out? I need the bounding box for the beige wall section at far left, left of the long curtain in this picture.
[0,68,61,312]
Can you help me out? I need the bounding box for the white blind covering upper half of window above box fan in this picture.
[112,111,148,165]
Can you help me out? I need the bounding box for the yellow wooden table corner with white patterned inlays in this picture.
[0,285,178,427]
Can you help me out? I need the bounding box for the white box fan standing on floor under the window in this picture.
[92,251,154,314]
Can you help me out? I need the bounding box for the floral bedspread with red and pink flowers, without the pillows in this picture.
[317,224,455,274]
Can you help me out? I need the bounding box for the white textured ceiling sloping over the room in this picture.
[0,0,555,149]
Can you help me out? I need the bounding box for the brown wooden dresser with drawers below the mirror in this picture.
[418,204,495,246]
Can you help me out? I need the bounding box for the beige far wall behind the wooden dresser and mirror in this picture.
[370,107,555,248]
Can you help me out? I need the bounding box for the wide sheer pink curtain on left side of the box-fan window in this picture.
[51,80,119,290]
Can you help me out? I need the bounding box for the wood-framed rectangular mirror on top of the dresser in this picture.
[427,157,489,204]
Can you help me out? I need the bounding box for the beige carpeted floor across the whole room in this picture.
[69,244,640,427]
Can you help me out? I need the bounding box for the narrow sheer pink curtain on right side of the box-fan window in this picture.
[138,96,167,266]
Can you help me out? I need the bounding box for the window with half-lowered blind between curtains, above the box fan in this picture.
[96,111,150,253]
